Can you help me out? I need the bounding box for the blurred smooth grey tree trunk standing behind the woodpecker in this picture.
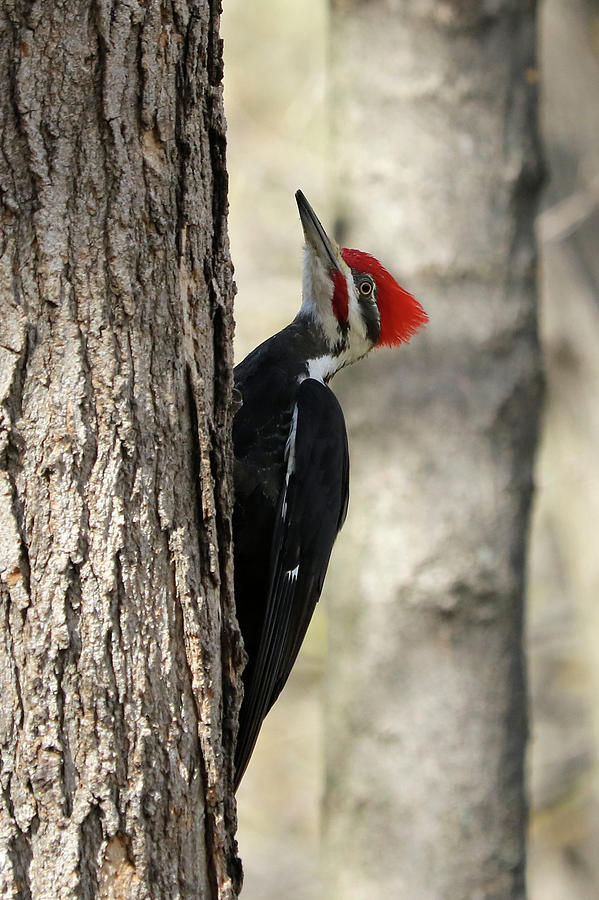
[325,0,540,900]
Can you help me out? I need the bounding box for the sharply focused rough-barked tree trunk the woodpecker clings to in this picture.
[0,0,238,900]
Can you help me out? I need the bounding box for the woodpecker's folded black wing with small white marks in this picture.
[235,378,349,785]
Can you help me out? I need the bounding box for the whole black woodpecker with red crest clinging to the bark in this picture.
[233,191,428,788]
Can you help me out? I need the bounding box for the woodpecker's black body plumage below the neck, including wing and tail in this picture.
[233,326,349,785]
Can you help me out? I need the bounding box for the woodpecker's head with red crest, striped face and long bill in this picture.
[295,191,428,377]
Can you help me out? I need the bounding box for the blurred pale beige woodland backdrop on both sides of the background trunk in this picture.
[222,0,599,900]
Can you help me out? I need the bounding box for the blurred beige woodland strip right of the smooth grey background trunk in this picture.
[527,0,599,900]
